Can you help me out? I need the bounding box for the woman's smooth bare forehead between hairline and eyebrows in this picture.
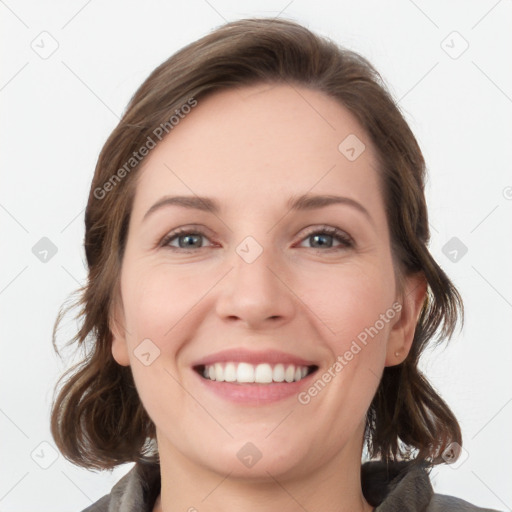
[130,84,380,215]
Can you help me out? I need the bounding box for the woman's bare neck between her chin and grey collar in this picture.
[153,430,374,512]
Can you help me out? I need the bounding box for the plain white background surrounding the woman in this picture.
[0,0,512,512]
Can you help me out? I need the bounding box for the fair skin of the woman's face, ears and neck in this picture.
[111,85,426,512]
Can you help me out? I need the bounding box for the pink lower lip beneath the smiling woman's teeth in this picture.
[194,371,317,405]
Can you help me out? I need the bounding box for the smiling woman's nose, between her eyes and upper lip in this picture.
[216,242,297,329]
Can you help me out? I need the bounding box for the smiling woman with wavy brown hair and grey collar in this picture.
[52,19,500,512]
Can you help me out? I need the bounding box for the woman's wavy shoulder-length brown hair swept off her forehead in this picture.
[51,18,463,469]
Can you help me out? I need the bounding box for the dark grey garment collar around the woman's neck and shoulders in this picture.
[82,461,499,512]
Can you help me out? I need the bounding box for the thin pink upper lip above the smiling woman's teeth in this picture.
[192,347,315,366]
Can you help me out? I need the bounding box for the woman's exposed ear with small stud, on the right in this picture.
[385,272,427,366]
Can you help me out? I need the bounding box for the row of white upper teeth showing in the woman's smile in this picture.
[203,362,308,384]
